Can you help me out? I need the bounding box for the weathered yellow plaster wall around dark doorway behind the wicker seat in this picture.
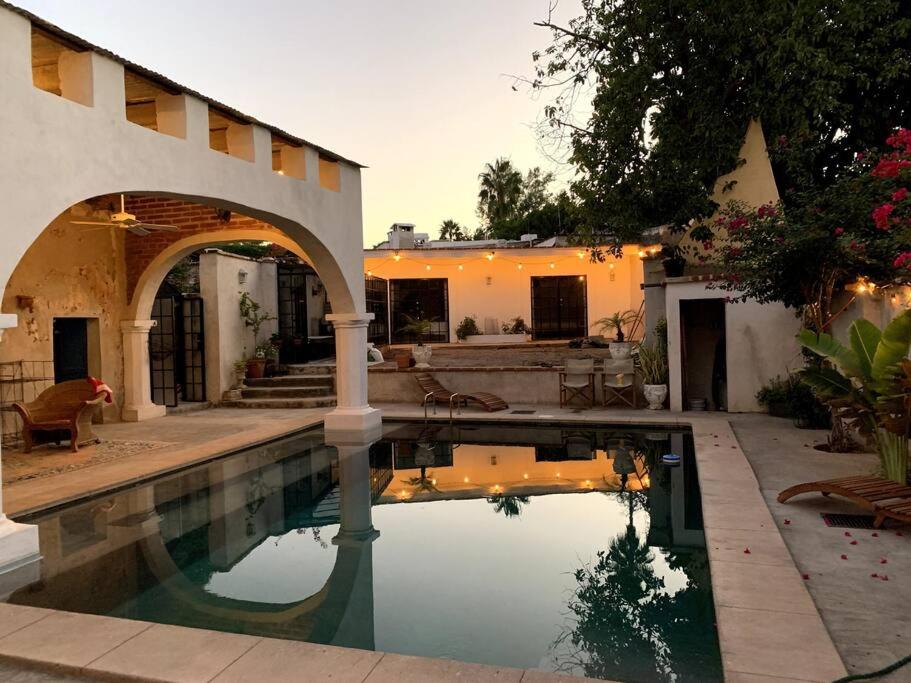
[0,212,127,420]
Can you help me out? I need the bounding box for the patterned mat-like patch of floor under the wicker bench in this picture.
[2,439,172,485]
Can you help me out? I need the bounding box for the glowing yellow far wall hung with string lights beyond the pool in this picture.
[364,246,642,342]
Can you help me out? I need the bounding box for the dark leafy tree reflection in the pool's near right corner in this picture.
[553,492,722,683]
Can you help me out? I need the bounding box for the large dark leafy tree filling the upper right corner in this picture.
[532,0,911,250]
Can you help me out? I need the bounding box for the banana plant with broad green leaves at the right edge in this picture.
[797,311,911,483]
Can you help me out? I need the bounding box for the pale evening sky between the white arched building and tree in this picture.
[13,0,580,246]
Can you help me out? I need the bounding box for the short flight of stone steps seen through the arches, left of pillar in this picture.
[221,365,335,408]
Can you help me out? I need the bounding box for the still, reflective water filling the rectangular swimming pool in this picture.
[10,423,722,682]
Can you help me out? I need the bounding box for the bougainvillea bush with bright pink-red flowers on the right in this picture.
[704,129,911,331]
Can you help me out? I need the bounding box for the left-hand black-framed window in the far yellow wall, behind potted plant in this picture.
[389,278,449,344]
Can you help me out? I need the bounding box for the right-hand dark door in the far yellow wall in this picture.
[531,275,588,339]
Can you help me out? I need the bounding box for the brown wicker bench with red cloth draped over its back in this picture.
[13,379,106,453]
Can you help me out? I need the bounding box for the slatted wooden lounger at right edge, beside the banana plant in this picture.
[778,476,911,528]
